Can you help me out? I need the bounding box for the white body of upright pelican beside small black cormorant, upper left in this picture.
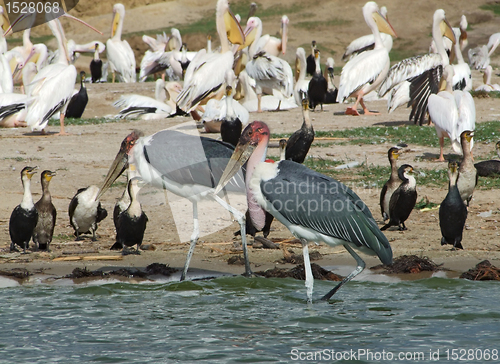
[106,39,136,82]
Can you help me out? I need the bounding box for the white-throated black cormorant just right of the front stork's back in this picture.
[380,164,417,231]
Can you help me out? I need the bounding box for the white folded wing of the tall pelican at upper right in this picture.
[338,48,389,102]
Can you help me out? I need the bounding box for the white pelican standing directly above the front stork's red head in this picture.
[241,17,293,112]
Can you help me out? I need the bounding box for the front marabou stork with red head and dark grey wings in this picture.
[215,121,392,301]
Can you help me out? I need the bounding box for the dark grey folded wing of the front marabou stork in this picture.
[260,160,392,264]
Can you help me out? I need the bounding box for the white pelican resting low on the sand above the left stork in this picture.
[113,78,176,120]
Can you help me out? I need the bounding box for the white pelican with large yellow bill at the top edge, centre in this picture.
[177,0,245,112]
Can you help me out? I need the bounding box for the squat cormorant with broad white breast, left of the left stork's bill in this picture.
[68,186,108,241]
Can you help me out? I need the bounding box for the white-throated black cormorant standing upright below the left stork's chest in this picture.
[116,177,148,252]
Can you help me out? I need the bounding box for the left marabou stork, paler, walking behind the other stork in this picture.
[97,130,251,281]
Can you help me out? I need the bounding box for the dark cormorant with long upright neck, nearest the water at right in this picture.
[439,162,467,249]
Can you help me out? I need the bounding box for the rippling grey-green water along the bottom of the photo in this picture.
[0,277,500,363]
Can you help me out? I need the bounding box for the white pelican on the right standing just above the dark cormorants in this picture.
[428,65,476,162]
